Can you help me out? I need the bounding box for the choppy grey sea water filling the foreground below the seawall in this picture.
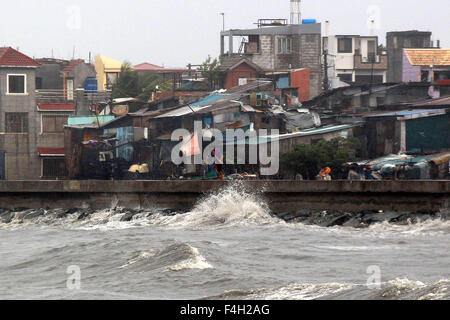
[0,186,450,300]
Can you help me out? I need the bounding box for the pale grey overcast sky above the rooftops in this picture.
[0,0,450,67]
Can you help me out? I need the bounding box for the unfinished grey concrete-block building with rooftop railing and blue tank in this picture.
[220,19,322,97]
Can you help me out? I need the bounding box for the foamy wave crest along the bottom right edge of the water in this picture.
[204,278,450,300]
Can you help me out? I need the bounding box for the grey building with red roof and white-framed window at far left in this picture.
[0,47,41,180]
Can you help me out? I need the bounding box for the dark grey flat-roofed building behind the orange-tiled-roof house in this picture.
[386,30,439,82]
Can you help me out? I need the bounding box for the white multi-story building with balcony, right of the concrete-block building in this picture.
[323,35,387,89]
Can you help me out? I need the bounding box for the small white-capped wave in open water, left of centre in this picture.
[119,242,213,272]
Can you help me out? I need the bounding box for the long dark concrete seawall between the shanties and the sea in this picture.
[0,180,450,212]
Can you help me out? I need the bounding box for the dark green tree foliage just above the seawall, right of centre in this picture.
[280,138,359,180]
